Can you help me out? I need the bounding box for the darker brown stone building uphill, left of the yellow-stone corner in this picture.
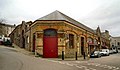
[10,21,31,48]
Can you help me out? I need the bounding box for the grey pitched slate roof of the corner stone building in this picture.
[37,10,94,33]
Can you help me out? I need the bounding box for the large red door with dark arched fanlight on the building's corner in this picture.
[43,29,58,58]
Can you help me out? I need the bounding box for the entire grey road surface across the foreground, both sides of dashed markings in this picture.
[0,46,120,70]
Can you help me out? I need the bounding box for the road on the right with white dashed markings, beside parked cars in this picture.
[61,53,120,70]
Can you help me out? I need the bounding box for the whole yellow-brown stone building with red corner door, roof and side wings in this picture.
[10,11,110,58]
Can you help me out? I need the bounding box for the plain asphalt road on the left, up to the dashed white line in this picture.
[0,46,78,70]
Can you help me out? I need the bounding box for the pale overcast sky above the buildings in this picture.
[0,0,120,37]
